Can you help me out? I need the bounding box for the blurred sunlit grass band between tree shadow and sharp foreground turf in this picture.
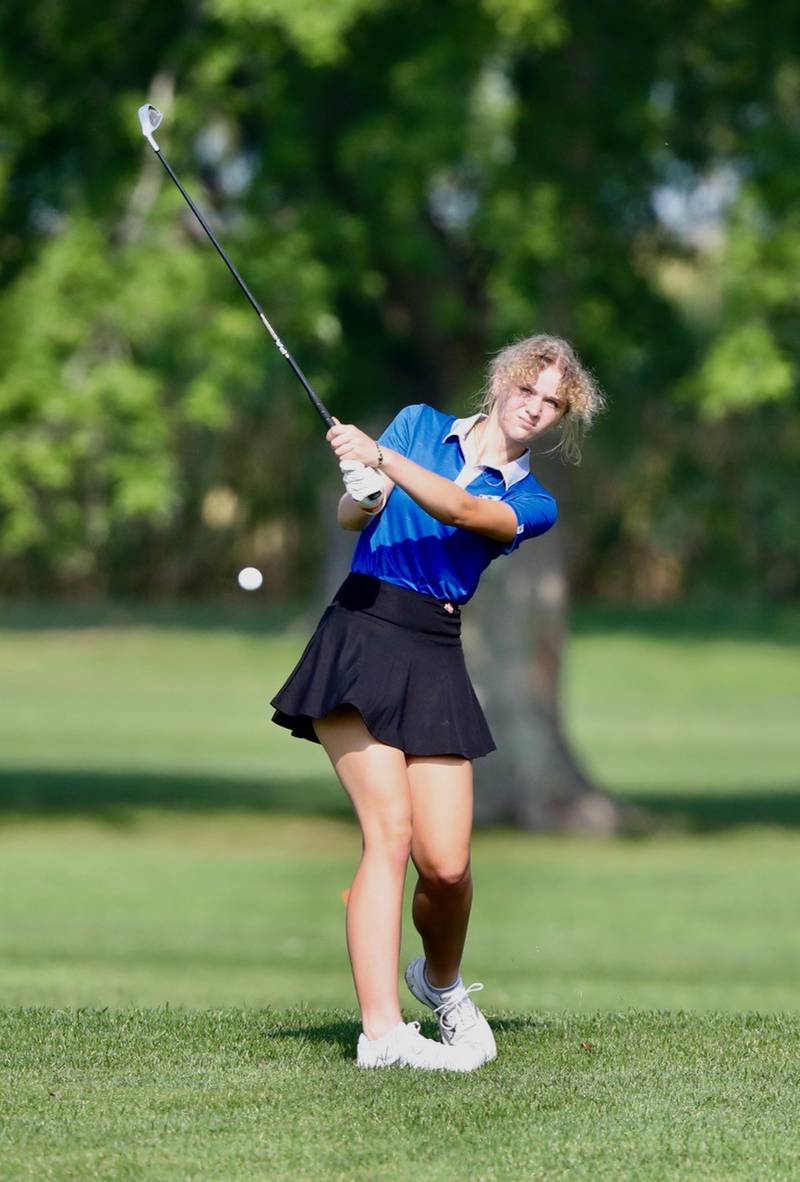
[0,812,800,1013]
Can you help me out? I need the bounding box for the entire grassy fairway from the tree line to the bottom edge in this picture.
[0,610,800,1182]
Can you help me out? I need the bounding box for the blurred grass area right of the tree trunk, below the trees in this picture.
[567,613,800,827]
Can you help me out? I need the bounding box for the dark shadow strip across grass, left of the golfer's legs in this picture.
[0,768,351,823]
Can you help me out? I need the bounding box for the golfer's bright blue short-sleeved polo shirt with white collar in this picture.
[351,403,558,603]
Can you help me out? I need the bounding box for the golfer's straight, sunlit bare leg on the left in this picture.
[314,707,411,1039]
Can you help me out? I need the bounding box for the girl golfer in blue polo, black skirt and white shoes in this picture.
[272,336,603,1071]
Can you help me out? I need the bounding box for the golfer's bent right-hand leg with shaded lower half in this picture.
[406,755,473,988]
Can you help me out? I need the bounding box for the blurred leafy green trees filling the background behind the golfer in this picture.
[0,0,800,599]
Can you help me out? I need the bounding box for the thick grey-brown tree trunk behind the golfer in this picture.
[464,449,624,833]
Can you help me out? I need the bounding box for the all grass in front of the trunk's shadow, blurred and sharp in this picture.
[0,810,800,1182]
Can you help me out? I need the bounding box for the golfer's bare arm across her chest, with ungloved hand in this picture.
[326,423,518,543]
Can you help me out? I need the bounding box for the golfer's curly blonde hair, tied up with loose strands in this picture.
[479,335,606,463]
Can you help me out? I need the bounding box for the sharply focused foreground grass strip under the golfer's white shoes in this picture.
[0,1009,800,1182]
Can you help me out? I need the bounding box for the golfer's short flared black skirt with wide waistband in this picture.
[272,574,495,759]
